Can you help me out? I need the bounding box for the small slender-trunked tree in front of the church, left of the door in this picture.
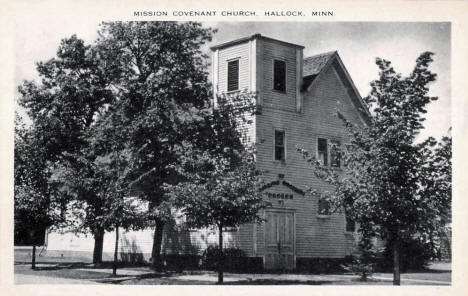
[166,93,267,284]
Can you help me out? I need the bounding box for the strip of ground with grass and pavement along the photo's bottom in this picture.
[14,249,451,285]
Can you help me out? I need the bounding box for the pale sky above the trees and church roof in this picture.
[15,19,451,139]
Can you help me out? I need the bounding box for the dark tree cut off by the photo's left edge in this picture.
[14,114,62,269]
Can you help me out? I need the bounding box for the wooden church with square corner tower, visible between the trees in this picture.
[47,34,370,269]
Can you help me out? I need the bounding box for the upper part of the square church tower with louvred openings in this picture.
[211,34,304,112]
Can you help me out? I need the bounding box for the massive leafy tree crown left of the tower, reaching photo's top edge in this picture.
[18,22,218,260]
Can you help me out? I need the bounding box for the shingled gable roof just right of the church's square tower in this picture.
[302,51,371,123]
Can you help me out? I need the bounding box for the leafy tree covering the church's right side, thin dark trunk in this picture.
[299,52,451,285]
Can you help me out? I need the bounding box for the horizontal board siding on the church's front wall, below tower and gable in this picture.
[252,58,366,258]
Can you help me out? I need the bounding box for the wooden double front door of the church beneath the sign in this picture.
[265,210,295,270]
